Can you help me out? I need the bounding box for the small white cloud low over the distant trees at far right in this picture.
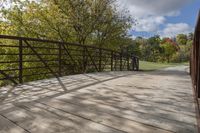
[160,23,193,37]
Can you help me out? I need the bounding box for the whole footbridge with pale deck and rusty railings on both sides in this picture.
[0,12,200,133]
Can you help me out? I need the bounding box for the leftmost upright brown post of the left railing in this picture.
[19,39,23,84]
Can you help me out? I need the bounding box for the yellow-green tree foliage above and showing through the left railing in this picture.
[0,0,135,84]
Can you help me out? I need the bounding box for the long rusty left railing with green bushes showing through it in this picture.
[0,35,139,86]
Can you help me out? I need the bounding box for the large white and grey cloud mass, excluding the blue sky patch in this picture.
[118,0,194,36]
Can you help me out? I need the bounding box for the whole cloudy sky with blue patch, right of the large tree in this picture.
[118,0,200,38]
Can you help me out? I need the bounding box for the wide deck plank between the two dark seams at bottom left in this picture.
[1,102,123,133]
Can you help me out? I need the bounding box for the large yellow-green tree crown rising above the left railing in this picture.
[1,0,134,48]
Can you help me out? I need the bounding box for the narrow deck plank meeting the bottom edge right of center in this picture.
[39,99,173,133]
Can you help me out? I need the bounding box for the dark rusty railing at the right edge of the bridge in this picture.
[190,12,200,98]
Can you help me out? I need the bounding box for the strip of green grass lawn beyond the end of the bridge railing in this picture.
[140,61,189,71]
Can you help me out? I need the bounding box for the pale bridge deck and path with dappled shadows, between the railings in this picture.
[0,66,197,133]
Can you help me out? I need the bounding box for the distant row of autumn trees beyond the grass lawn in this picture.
[129,33,193,62]
